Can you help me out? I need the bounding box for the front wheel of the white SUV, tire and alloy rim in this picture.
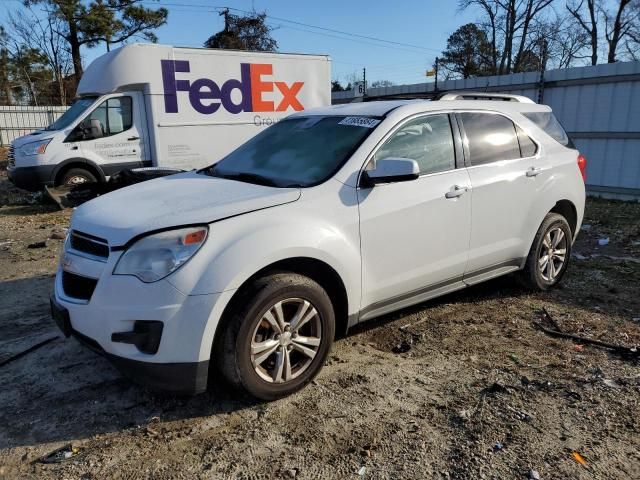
[214,273,335,400]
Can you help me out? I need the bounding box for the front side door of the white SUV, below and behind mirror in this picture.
[358,113,471,319]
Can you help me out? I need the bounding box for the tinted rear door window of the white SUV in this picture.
[460,112,520,165]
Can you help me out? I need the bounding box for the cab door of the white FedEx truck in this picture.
[79,92,148,176]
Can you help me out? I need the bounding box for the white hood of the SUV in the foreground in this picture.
[71,172,300,247]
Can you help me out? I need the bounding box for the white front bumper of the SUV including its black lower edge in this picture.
[51,249,233,394]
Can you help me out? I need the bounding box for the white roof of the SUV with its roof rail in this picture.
[292,96,551,117]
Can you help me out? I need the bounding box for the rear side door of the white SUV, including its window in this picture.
[457,112,550,283]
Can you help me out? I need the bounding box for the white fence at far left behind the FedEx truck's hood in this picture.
[0,106,68,147]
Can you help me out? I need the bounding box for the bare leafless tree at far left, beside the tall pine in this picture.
[8,6,71,105]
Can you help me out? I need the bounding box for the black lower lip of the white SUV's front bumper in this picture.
[50,294,209,395]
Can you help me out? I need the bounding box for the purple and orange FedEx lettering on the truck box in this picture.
[161,60,304,114]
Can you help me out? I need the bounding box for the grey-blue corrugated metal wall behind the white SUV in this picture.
[332,62,640,198]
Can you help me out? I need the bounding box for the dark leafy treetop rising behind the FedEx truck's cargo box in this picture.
[204,10,278,52]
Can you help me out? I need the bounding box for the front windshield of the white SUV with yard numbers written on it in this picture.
[205,115,380,187]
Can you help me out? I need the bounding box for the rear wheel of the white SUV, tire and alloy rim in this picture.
[520,213,572,291]
